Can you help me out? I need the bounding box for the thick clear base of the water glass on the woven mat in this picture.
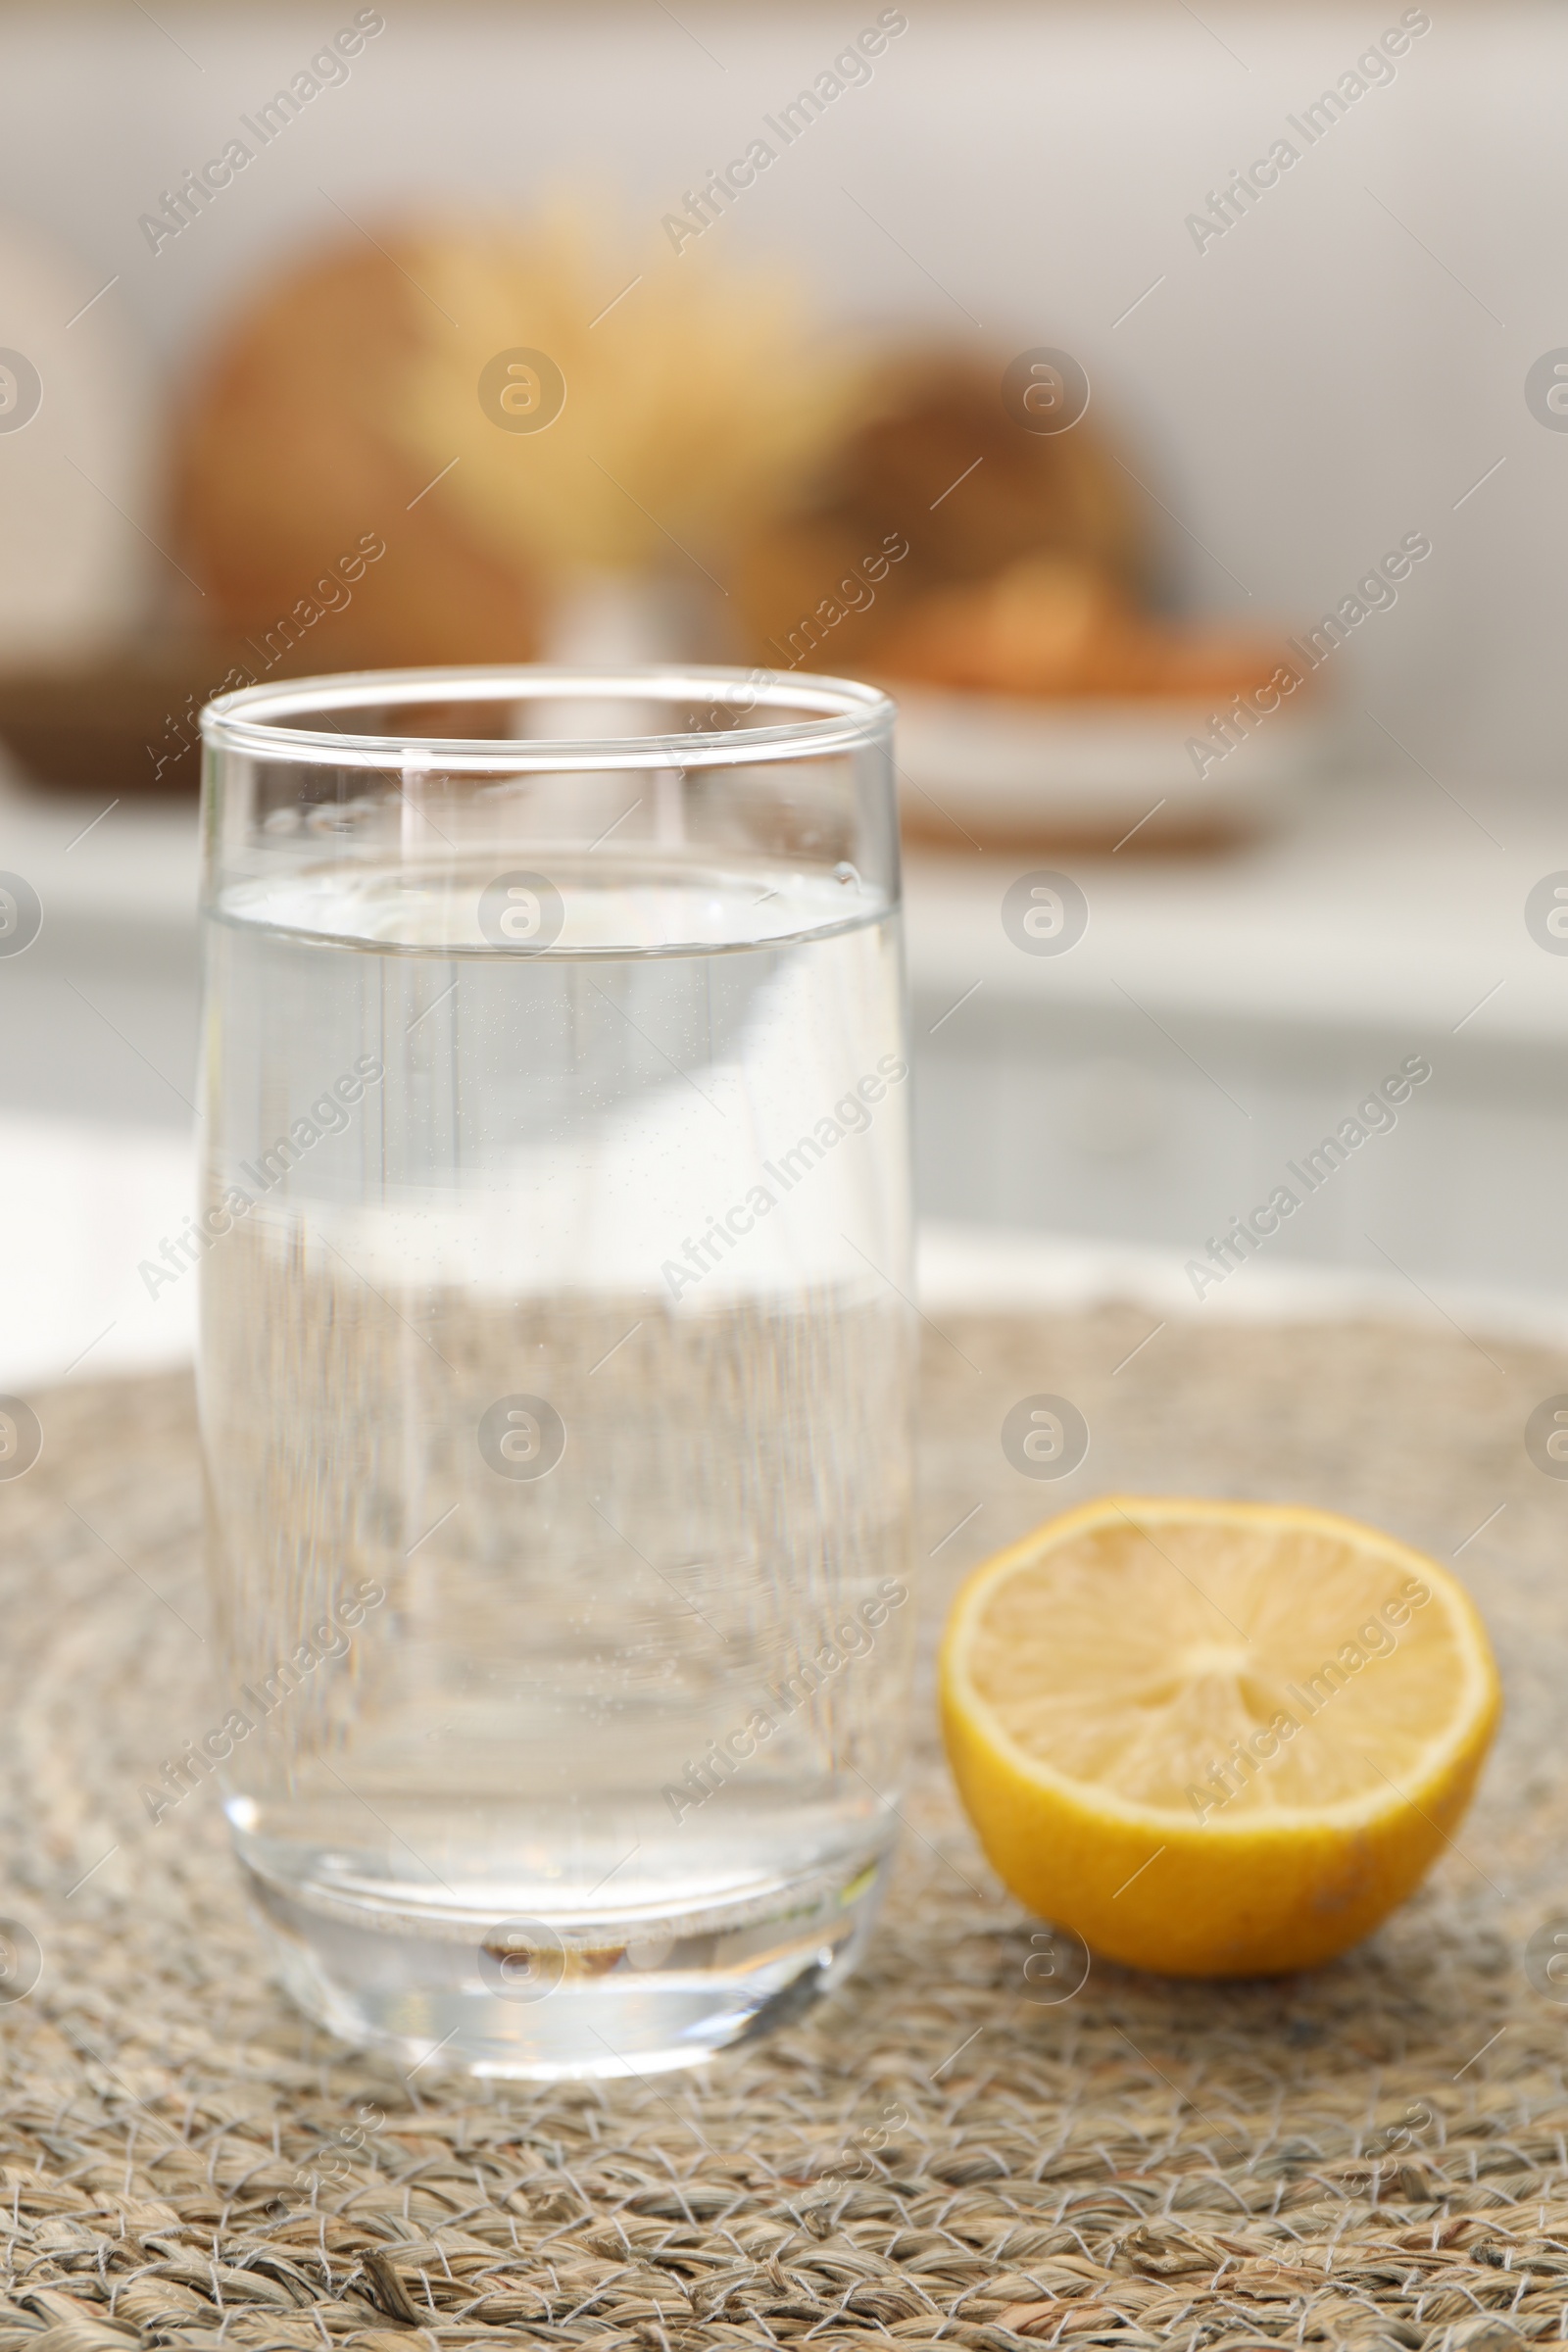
[242,1848,889,2082]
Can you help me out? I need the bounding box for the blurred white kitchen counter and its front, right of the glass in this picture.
[909,771,1568,1296]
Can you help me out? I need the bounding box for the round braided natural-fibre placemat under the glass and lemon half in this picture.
[0,1307,1568,2352]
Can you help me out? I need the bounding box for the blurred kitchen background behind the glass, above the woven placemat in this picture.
[0,0,1568,1386]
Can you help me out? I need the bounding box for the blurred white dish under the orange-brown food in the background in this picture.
[889,680,1333,852]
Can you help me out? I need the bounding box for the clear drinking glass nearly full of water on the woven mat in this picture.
[193,668,914,2077]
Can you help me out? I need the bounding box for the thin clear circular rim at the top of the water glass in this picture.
[202,661,896,771]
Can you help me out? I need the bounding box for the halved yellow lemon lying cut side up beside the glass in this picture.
[941,1495,1499,1976]
